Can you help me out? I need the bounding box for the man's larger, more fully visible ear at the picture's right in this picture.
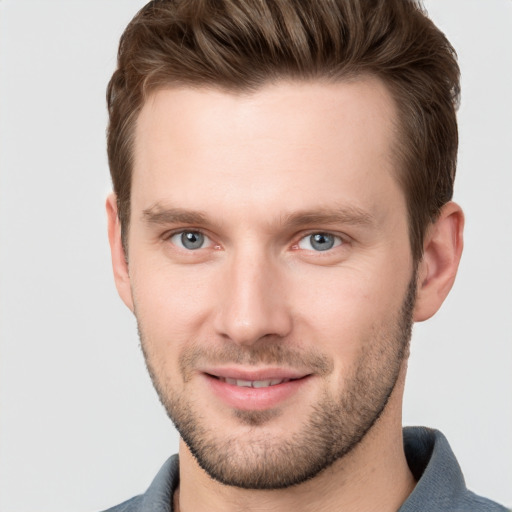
[414,202,464,322]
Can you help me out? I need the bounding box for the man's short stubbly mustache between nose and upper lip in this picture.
[179,342,334,380]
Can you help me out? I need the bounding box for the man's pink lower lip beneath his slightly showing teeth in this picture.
[205,374,311,411]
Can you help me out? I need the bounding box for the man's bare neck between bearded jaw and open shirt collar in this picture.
[174,372,415,512]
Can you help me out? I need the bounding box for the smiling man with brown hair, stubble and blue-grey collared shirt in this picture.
[102,0,505,512]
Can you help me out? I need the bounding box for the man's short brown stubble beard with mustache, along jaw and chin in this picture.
[139,273,416,489]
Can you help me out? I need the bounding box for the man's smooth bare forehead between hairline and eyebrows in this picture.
[132,77,404,222]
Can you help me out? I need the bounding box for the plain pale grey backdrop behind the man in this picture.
[0,0,512,512]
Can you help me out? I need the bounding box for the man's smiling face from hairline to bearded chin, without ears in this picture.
[121,79,415,488]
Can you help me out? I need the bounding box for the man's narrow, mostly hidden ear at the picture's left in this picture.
[106,193,133,312]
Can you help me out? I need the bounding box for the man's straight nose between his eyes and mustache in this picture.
[215,253,292,346]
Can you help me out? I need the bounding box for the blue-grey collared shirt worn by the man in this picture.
[100,427,510,512]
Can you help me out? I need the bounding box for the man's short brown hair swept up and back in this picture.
[107,0,460,260]
